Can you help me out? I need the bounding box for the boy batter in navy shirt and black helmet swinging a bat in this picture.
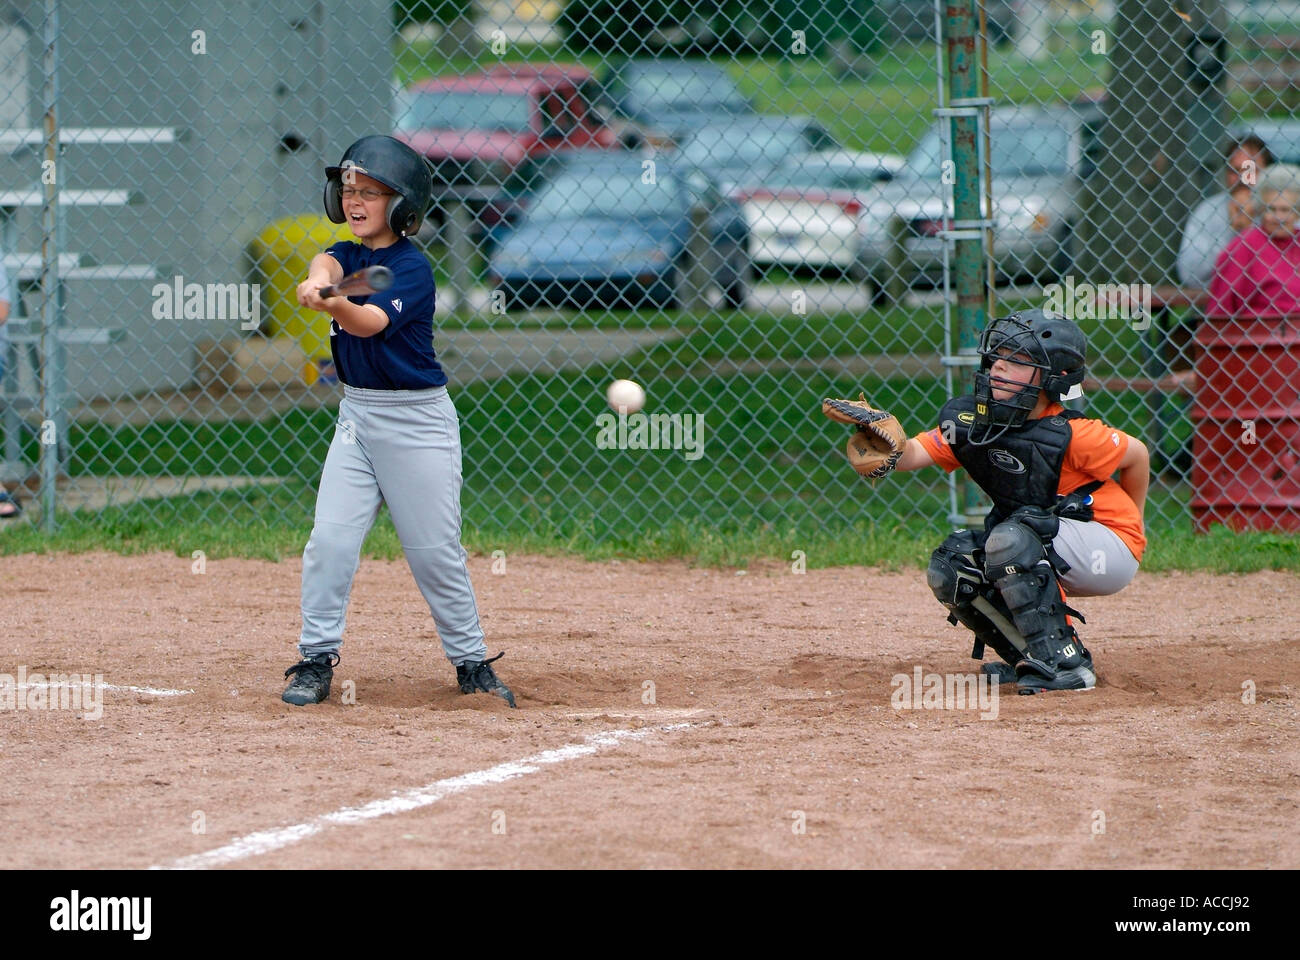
[282,137,515,706]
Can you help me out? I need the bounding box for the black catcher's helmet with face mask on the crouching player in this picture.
[970,310,1088,446]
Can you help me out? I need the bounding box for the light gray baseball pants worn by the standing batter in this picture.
[298,385,488,665]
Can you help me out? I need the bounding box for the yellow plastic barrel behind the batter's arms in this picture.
[250,213,355,358]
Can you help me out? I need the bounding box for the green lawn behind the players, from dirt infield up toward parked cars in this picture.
[0,329,1300,572]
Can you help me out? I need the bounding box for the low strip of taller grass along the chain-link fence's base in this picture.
[0,476,1300,574]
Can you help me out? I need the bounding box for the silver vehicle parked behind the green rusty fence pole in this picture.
[858,105,1100,290]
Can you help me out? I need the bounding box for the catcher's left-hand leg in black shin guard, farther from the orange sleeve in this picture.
[926,529,1024,683]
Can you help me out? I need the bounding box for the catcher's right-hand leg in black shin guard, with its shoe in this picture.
[984,520,1097,693]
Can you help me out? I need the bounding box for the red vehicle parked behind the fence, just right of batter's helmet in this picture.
[394,64,616,234]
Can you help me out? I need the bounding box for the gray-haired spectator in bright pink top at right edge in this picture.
[1205,164,1300,319]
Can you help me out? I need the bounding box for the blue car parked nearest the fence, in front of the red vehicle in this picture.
[489,153,751,308]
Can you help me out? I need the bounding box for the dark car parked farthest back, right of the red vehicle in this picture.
[599,60,754,140]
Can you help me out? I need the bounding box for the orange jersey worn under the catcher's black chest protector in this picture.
[915,403,1147,561]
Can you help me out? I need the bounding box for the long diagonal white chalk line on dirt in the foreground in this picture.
[150,723,699,870]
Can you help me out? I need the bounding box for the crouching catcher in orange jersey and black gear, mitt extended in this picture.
[822,310,1149,693]
